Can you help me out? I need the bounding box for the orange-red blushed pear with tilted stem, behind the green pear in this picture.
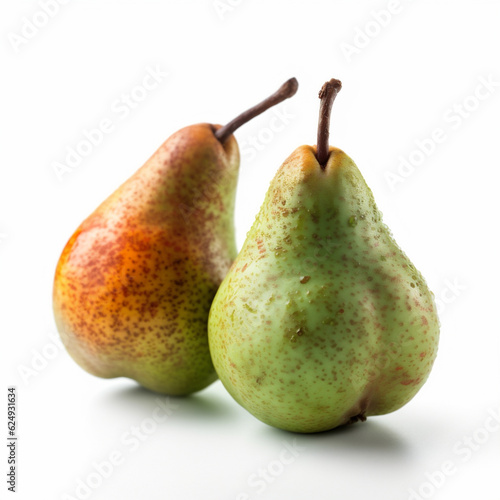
[53,78,298,395]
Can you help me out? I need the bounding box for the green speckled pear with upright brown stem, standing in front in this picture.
[209,80,439,433]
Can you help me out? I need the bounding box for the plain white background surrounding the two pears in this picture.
[0,0,500,500]
